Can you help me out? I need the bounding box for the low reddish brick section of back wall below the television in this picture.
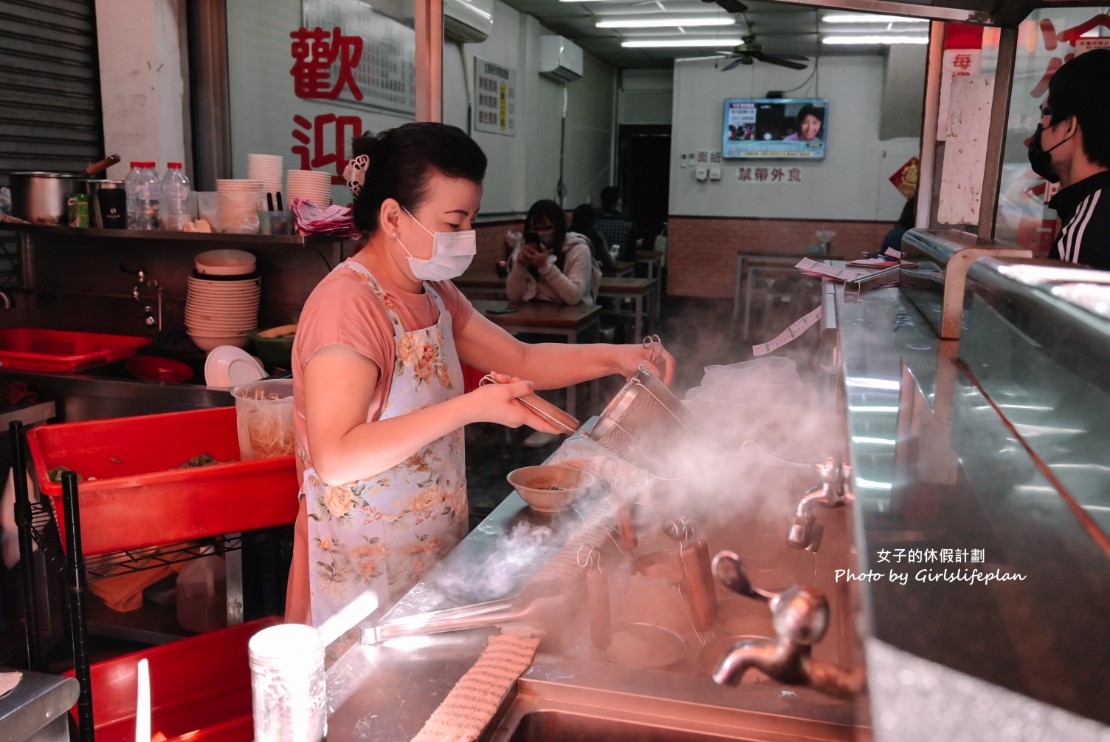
[666,217,892,298]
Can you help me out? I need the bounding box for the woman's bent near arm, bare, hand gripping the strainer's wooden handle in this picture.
[304,344,556,484]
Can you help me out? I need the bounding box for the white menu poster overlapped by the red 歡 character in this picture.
[304,0,416,114]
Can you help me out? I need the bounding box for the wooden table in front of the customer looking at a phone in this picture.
[471,299,602,418]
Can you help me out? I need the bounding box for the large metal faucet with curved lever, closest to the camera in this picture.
[713,551,865,699]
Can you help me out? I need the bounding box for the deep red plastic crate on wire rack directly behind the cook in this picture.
[28,407,299,557]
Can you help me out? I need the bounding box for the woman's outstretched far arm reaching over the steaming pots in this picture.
[455,312,675,390]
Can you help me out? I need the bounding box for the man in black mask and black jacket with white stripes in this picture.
[1029,49,1110,270]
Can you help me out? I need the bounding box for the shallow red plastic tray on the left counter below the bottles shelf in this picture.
[0,328,150,371]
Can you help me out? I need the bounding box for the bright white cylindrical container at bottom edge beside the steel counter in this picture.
[248,623,327,742]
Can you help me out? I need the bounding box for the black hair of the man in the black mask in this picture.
[1048,49,1110,168]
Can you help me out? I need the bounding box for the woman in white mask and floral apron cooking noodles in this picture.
[285,122,674,631]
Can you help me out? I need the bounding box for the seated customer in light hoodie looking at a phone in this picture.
[505,199,601,304]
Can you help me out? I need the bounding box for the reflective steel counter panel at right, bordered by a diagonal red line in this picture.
[838,282,1110,740]
